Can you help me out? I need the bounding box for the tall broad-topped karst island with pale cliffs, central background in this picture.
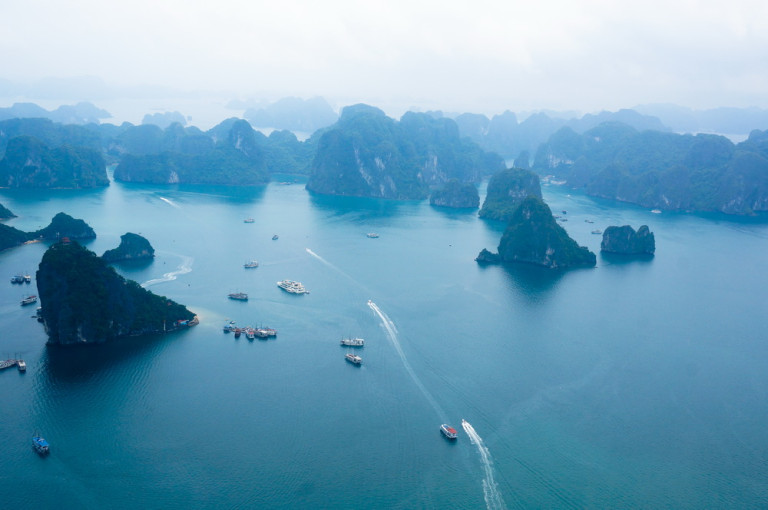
[307,104,503,199]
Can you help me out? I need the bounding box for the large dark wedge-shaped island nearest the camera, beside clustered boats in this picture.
[36,242,194,345]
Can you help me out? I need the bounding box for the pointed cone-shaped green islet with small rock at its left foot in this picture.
[476,197,596,269]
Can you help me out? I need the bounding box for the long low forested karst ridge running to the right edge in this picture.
[534,124,768,214]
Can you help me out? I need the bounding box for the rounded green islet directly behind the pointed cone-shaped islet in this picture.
[479,168,541,221]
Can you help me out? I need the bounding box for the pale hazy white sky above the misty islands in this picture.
[0,0,768,113]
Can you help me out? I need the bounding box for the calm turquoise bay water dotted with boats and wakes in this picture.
[0,178,768,509]
